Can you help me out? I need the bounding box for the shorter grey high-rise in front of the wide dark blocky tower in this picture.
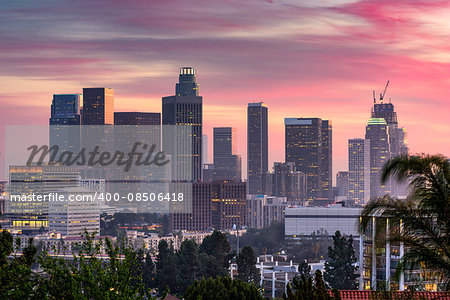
[265,162,306,202]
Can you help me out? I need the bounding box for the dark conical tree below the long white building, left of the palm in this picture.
[324,230,359,290]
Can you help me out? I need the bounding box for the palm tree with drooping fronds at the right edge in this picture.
[360,155,450,290]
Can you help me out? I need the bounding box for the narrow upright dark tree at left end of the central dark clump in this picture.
[156,240,177,293]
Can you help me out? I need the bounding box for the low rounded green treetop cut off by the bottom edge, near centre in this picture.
[183,276,263,300]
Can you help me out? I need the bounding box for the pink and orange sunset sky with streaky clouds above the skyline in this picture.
[0,0,450,180]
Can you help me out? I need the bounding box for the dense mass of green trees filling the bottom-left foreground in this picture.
[0,231,239,299]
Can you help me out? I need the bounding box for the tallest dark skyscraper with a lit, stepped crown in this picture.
[162,67,203,181]
